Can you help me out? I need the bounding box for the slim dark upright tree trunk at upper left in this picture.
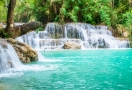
[6,0,16,36]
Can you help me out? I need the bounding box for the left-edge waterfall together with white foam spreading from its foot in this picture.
[0,39,54,78]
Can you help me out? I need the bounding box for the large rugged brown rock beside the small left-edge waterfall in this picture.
[7,38,38,63]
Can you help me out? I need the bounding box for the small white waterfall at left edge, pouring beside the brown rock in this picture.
[0,40,22,73]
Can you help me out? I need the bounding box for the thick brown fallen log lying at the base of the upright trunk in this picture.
[0,22,43,38]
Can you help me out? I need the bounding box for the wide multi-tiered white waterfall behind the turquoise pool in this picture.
[16,23,130,50]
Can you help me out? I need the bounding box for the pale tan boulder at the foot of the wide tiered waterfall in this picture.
[63,42,81,49]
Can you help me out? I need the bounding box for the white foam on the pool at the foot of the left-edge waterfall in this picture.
[0,64,59,78]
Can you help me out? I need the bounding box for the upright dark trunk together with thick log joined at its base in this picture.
[5,0,42,38]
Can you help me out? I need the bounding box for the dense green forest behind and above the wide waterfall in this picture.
[0,0,132,36]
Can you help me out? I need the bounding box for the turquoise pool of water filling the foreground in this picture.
[0,49,132,90]
